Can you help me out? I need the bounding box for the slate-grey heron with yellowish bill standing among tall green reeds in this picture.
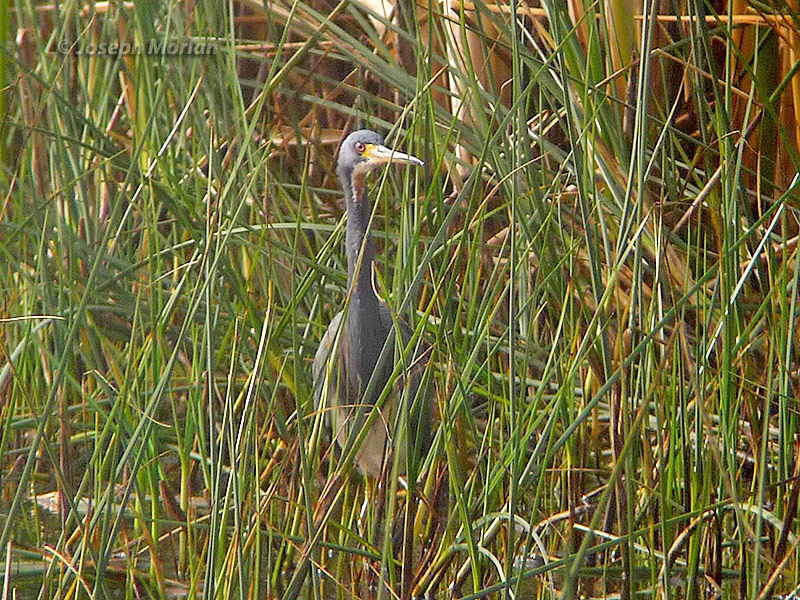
[313,129,432,479]
